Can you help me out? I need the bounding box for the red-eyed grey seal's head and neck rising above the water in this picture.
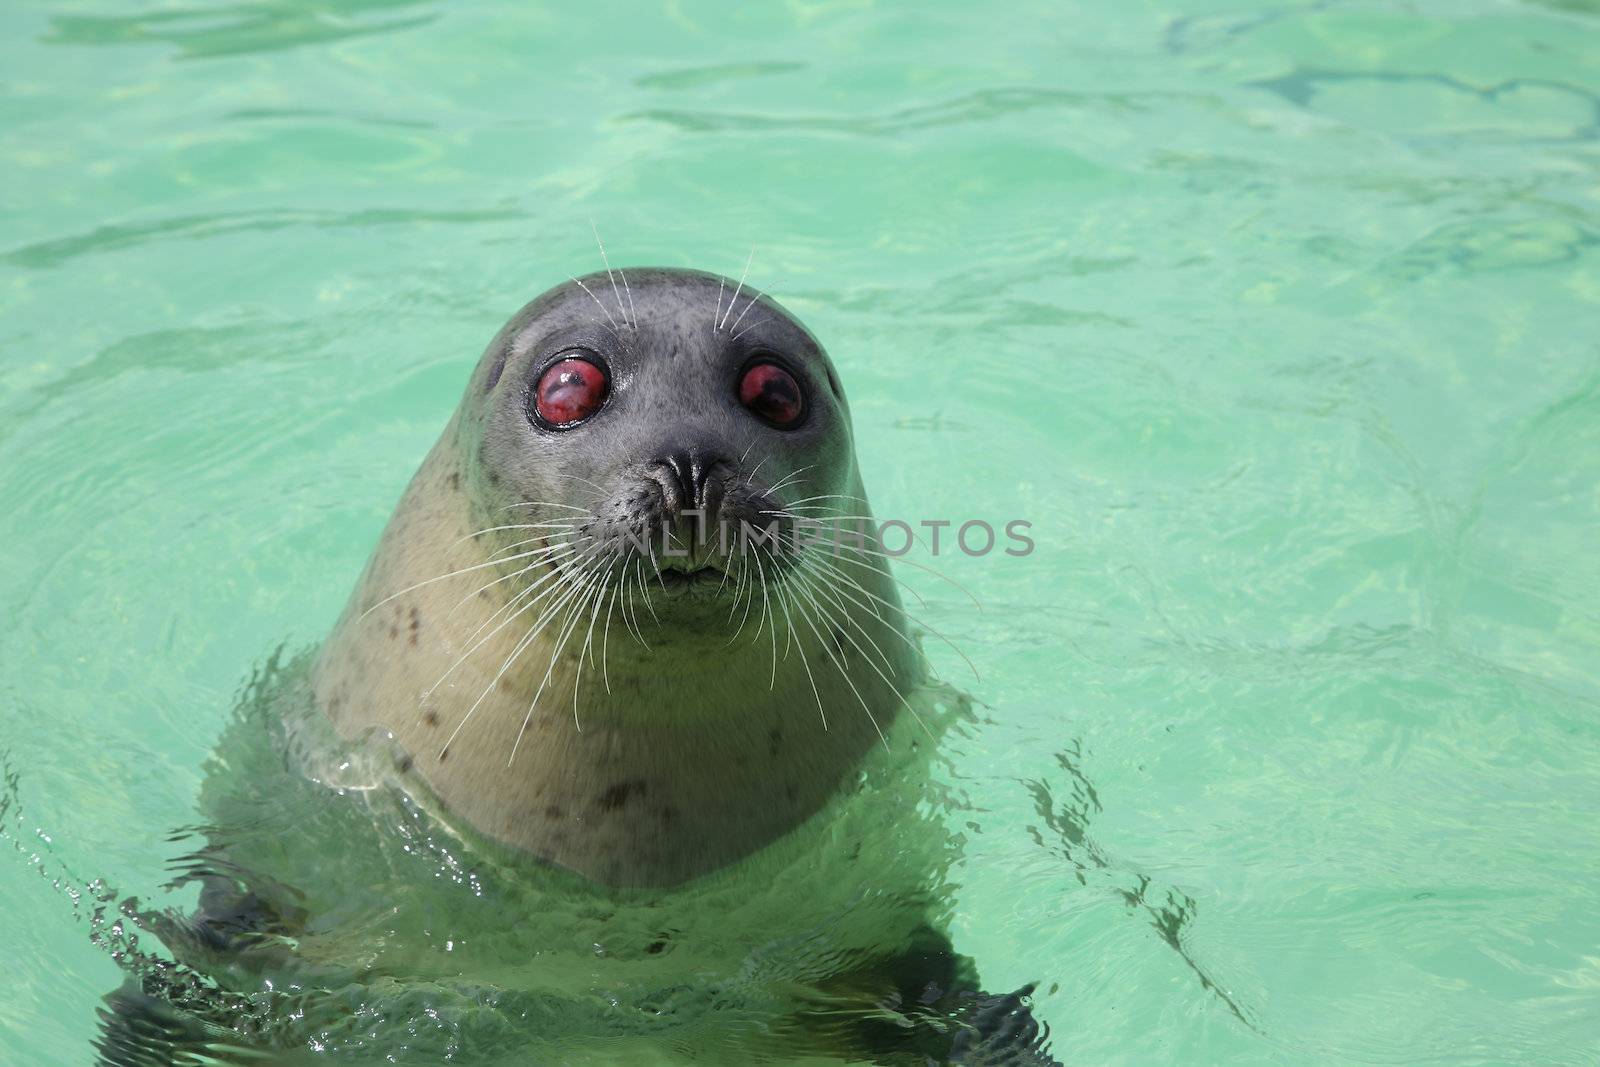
[314,269,922,885]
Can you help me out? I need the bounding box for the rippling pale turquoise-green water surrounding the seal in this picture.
[0,0,1600,1064]
